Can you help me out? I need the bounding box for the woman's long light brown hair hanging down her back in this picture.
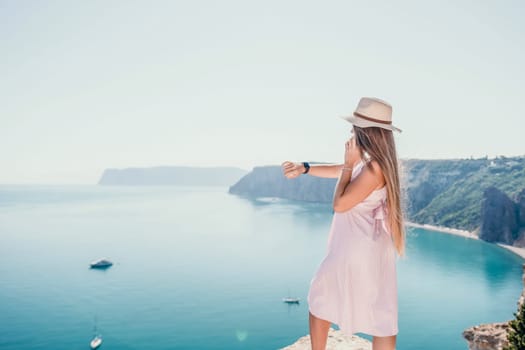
[353,125,406,256]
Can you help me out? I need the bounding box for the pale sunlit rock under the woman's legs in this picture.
[281,328,372,350]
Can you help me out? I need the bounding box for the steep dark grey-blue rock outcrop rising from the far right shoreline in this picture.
[479,186,520,245]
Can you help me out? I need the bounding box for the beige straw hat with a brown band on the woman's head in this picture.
[341,97,401,132]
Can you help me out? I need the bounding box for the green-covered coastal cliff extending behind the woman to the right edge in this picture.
[229,156,525,247]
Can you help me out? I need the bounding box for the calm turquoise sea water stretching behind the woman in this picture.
[0,185,523,350]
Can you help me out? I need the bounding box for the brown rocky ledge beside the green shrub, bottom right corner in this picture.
[463,264,525,350]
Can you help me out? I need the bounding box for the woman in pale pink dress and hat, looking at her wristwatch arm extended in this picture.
[282,97,405,350]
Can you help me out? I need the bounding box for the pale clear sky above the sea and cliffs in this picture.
[0,0,525,184]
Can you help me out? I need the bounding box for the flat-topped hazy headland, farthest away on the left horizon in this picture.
[98,166,247,186]
